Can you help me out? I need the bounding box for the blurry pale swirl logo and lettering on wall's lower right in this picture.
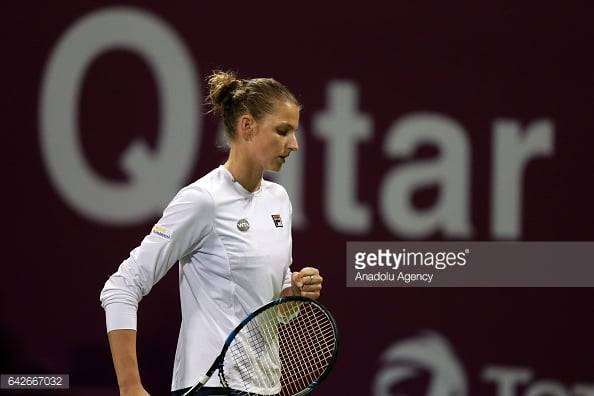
[372,331,594,396]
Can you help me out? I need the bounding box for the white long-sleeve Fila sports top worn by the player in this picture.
[100,165,292,390]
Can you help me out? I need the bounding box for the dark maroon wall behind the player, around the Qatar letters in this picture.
[0,0,594,396]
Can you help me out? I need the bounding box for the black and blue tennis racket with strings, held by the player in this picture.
[184,296,339,396]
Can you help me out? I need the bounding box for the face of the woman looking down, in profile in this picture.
[252,101,299,172]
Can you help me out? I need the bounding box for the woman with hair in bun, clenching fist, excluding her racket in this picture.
[100,71,323,396]
